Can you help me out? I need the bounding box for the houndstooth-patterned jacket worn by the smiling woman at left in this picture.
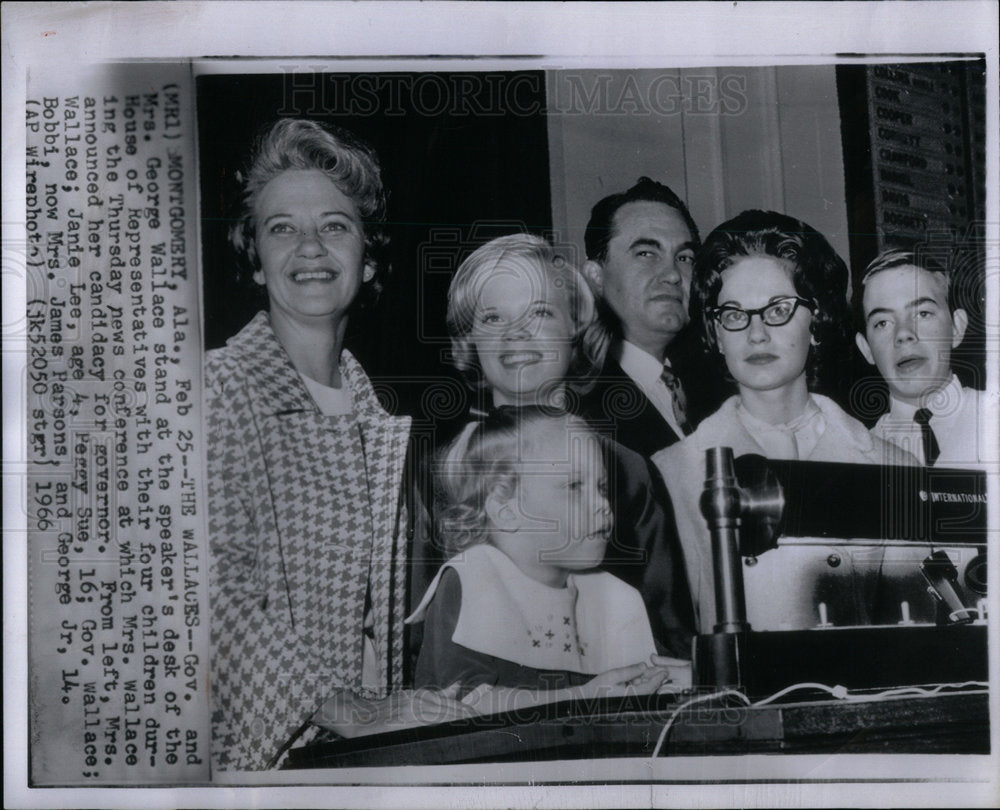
[205,312,410,770]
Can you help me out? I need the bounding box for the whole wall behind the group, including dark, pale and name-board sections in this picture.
[198,60,986,424]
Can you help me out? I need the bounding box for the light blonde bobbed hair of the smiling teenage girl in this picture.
[446,233,608,394]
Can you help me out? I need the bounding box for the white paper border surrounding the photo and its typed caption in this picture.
[2,0,1000,807]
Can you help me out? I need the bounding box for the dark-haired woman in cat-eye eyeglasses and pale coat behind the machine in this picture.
[653,211,915,633]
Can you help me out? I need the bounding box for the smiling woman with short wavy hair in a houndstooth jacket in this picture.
[205,119,418,769]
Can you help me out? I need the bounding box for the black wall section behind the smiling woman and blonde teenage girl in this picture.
[198,72,552,418]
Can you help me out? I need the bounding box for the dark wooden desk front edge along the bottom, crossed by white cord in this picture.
[286,692,990,768]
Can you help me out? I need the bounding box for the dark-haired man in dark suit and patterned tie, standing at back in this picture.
[583,177,707,458]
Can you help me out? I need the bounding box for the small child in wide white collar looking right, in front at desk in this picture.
[407,407,680,713]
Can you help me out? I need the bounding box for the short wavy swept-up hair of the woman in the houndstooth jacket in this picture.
[229,118,389,306]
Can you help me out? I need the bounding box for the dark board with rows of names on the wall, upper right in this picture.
[837,59,986,272]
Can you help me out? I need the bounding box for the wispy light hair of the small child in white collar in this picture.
[435,406,591,557]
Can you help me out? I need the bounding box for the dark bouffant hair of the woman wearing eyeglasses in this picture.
[690,211,851,393]
